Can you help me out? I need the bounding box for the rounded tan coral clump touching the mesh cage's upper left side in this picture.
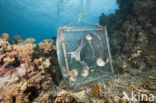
[39,40,56,54]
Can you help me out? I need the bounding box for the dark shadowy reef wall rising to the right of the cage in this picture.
[100,0,156,69]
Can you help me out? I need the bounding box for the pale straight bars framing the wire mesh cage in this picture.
[58,26,114,87]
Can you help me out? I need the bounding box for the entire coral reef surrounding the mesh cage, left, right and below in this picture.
[0,0,156,103]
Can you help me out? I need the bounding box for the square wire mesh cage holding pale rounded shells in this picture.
[57,27,113,87]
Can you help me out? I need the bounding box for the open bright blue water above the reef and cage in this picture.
[0,0,118,42]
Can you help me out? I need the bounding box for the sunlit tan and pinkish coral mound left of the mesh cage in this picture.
[0,34,60,103]
